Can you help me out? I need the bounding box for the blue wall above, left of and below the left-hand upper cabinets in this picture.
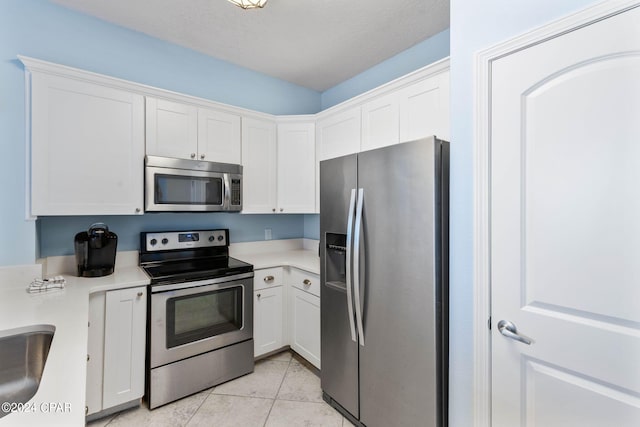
[0,0,320,265]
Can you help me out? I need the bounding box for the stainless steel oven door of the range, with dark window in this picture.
[149,274,253,368]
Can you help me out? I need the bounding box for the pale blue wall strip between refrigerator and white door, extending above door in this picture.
[449,0,595,427]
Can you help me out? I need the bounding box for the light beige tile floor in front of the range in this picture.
[88,351,351,427]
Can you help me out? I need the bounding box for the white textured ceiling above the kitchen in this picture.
[50,0,449,91]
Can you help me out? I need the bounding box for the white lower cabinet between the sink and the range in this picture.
[86,286,147,415]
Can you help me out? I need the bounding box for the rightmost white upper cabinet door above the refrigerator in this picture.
[400,71,450,142]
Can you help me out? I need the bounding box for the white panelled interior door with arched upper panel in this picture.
[491,7,640,427]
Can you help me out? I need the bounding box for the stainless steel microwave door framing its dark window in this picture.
[145,166,231,212]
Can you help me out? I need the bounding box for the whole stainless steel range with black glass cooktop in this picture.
[140,229,253,409]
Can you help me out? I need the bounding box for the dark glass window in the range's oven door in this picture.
[167,286,242,348]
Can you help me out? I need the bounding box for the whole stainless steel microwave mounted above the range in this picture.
[144,156,242,212]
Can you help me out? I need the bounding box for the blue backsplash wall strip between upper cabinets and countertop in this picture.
[37,213,308,258]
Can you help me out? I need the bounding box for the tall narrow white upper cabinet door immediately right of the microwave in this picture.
[242,118,277,213]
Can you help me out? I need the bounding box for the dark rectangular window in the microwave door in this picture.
[154,174,223,205]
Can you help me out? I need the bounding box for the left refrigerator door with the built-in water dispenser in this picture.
[320,155,359,418]
